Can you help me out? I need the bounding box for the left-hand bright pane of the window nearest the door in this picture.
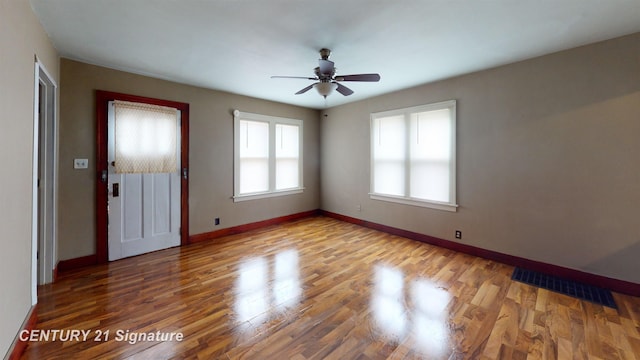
[239,120,269,194]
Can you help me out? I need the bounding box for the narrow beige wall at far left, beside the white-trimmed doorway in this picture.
[0,0,58,356]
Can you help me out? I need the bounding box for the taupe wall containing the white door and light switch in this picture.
[58,59,320,260]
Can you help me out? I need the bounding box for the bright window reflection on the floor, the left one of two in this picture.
[234,249,302,339]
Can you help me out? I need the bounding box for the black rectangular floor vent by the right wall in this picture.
[511,268,618,309]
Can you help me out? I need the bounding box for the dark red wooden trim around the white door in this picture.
[96,90,189,263]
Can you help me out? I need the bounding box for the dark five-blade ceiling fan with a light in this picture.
[271,49,380,99]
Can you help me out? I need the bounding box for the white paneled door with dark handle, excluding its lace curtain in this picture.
[108,100,180,261]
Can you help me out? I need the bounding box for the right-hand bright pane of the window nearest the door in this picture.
[275,124,300,190]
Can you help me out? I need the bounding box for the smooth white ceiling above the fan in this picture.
[30,0,640,109]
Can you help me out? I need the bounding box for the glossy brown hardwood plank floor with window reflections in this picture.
[22,217,640,360]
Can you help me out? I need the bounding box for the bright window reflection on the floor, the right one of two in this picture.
[371,265,450,357]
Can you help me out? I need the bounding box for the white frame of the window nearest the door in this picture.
[233,110,304,202]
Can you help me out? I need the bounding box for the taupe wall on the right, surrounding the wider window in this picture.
[321,34,640,283]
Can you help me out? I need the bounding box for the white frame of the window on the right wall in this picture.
[369,100,458,212]
